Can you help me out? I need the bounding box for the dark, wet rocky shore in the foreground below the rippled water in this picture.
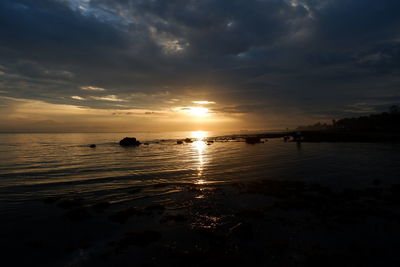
[3,179,400,266]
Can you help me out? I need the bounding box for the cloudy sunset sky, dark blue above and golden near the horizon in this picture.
[0,0,400,132]
